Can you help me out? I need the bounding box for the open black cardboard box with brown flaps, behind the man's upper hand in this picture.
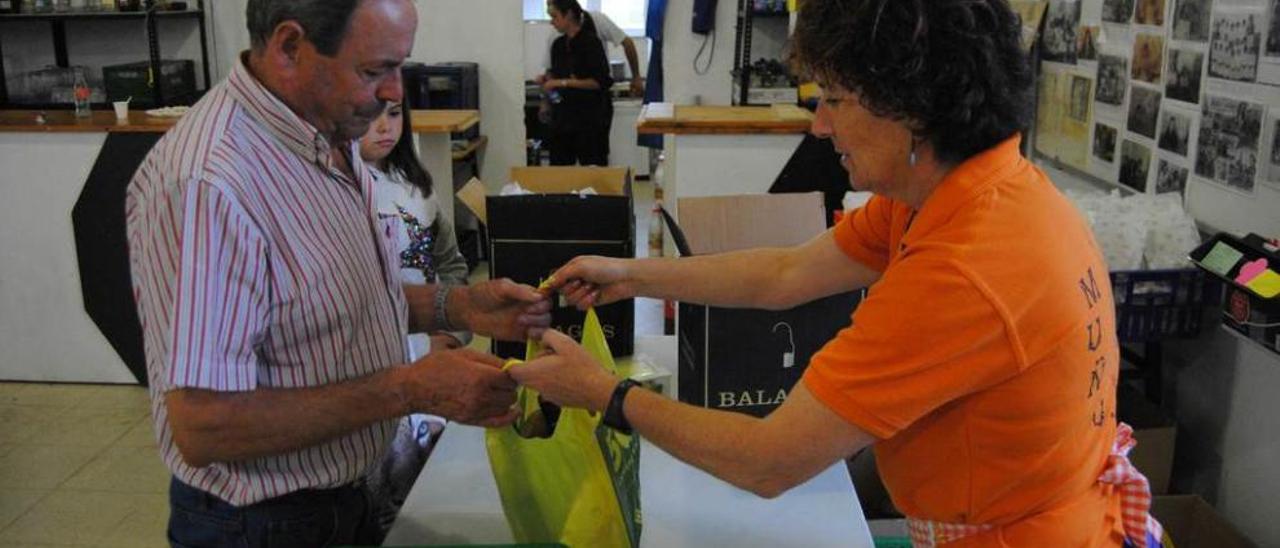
[457,166,635,357]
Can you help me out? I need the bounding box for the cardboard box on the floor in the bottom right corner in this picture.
[1151,494,1257,548]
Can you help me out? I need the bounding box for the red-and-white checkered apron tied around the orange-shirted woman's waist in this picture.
[906,423,1164,548]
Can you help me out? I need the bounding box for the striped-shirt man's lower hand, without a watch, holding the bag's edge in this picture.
[398,348,516,428]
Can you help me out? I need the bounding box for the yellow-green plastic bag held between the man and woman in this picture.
[485,310,641,548]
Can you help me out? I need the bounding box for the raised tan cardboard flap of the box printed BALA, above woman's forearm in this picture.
[678,192,827,255]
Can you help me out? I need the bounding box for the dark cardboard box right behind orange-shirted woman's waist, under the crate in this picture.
[1116,385,1178,494]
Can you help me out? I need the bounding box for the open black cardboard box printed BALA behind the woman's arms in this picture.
[672,192,861,416]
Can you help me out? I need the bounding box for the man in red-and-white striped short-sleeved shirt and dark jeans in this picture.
[127,0,549,547]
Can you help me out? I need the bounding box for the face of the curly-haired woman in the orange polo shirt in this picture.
[812,86,911,196]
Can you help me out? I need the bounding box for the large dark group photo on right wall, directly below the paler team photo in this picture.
[1196,95,1262,193]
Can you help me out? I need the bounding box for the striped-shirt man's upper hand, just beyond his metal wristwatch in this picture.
[447,278,552,341]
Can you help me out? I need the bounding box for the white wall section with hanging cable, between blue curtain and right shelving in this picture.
[662,0,737,105]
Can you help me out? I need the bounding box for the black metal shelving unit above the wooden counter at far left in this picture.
[0,0,209,110]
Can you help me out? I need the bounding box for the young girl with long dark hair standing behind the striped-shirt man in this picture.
[360,96,471,536]
